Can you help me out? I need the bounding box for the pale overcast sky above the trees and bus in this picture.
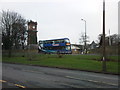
[0,0,120,44]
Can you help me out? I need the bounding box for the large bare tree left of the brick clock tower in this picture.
[0,10,26,57]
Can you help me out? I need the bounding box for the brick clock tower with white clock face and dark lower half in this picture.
[28,20,37,45]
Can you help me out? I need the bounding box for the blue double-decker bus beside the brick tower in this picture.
[38,38,72,54]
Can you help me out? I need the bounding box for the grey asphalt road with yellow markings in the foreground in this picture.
[0,63,118,88]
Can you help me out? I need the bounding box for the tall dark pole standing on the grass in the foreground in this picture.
[102,0,106,72]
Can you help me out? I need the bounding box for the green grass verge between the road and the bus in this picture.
[3,54,118,73]
